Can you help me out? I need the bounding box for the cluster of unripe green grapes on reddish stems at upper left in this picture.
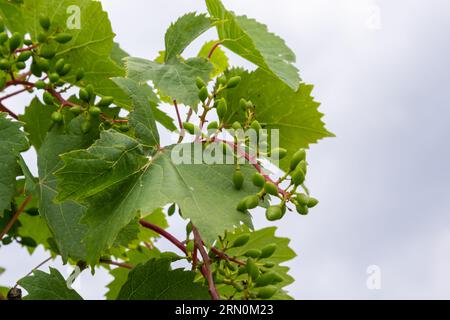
[0,17,119,133]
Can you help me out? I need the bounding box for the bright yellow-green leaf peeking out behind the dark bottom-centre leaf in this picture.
[106,247,160,300]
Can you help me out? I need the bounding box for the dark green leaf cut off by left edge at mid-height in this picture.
[0,112,28,213]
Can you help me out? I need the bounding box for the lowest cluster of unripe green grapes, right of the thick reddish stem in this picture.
[210,233,283,300]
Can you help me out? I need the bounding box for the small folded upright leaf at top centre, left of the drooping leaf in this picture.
[165,12,211,62]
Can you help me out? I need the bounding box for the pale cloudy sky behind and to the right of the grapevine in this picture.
[0,0,450,299]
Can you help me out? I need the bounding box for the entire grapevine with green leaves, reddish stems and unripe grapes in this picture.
[0,0,333,300]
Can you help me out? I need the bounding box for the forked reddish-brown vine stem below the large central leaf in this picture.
[139,219,219,300]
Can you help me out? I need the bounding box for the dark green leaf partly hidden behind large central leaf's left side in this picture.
[38,116,97,260]
